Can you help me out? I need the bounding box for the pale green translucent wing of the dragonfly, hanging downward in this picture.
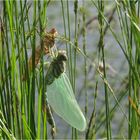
[47,73,86,131]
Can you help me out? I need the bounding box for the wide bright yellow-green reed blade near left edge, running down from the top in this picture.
[6,1,17,135]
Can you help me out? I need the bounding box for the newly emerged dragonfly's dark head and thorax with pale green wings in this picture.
[45,51,86,131]
